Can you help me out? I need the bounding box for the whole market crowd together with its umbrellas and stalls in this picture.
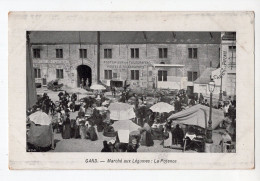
[26,80,236,152]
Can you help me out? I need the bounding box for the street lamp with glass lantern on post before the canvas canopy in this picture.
[206,78,215,143]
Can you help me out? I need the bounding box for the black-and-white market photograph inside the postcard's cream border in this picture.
[24,31,237,154]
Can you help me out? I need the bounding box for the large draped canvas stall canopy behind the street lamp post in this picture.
[168,104,224,129]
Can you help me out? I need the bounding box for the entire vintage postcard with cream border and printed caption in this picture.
[8,12,255,169]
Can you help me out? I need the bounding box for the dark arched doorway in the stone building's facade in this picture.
[77,65,92,87]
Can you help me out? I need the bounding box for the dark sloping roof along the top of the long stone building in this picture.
[30,31,221,44]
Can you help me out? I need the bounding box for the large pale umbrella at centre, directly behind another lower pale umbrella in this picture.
[108,102,135,120]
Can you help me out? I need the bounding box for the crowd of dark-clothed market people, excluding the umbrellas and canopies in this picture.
[27,87,236,152]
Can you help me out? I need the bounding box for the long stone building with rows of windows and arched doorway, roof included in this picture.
[31,32,220,92]
